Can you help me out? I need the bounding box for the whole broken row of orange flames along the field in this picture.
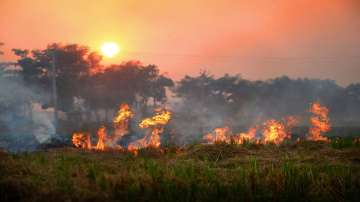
[72,100,334,153]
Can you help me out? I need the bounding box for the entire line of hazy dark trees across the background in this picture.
[0,44,360,140]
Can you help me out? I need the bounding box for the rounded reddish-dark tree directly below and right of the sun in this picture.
[85,61,174,112]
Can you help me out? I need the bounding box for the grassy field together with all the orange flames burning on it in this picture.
[0,102,360,201]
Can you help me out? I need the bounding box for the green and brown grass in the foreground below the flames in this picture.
[0,142,360,201]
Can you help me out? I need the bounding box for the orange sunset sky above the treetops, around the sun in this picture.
[0,0,360,85]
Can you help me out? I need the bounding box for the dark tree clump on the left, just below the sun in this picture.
[13,44,173,112]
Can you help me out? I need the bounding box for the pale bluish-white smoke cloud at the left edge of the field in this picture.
[0,74,56,151]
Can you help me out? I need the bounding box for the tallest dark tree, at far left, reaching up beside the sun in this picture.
[13,44,101,111]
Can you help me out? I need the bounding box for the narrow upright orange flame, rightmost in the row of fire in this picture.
[307,102,331,141]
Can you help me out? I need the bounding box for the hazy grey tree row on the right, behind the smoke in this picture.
[174,72,360,127]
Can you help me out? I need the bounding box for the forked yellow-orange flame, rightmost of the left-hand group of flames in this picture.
[128,109,171,153]
